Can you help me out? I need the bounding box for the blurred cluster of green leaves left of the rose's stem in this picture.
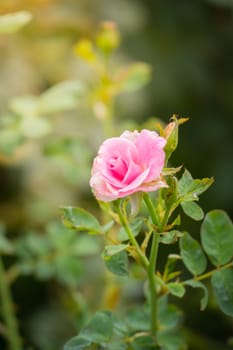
[15,223,100,285]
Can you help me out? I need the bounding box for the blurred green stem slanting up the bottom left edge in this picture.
[0,257,22,350]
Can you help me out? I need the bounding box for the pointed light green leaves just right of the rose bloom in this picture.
[178,169,214,201]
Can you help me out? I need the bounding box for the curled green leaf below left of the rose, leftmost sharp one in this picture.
[62,207,101,234]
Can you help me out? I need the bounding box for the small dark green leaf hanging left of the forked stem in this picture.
[105,250,128,276]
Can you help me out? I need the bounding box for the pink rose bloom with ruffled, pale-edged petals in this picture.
[90,130,167,202]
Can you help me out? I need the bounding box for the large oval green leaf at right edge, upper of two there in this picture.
[201,210,233,266]
